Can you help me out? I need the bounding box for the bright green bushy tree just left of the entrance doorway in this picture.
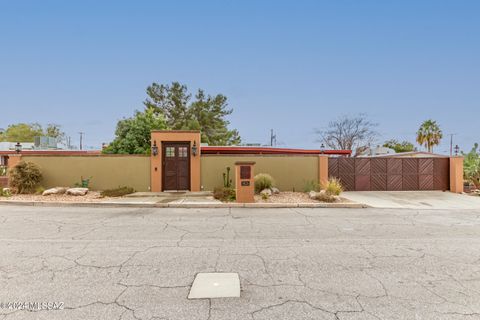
[103,108,167,154]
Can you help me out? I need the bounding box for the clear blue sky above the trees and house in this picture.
[0,0,480,152]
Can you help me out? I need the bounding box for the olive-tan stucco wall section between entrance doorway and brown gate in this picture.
[201,155,319,191]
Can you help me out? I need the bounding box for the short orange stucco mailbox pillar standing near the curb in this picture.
[235,161,255,203]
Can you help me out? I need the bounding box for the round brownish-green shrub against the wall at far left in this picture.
[9,161,42,193]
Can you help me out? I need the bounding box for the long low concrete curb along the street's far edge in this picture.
[0,200,368,209]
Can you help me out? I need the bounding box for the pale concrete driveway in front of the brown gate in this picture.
[342,191,480,209]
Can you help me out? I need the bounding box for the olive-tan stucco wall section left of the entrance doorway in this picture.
[22,155,150,191]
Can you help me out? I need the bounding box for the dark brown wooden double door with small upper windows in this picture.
[162,142,190,191]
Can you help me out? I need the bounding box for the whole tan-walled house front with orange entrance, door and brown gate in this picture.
[0,130,463,192]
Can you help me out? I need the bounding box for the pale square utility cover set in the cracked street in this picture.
[188,273,240,299]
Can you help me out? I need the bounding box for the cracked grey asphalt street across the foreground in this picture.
[0,206,480,320]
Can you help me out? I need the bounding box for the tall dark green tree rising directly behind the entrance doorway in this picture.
[144,82,241,145]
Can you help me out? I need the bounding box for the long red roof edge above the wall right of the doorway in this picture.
[200,146,352,156]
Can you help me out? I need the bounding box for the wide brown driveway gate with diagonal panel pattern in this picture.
[328,158,450,191]
